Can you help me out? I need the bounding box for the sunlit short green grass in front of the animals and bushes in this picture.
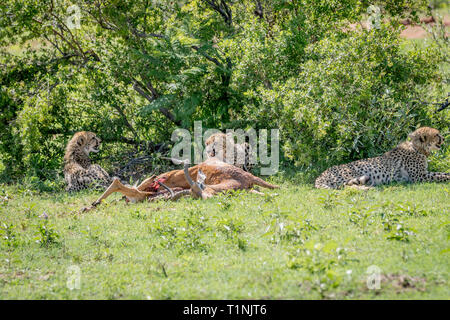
[0,179,450,299]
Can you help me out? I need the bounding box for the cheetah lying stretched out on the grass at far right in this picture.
[315,127,450,189]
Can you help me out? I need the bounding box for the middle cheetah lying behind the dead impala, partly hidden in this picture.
[205,132,253,171]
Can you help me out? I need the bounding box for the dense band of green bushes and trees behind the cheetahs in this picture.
[0,0,450,190]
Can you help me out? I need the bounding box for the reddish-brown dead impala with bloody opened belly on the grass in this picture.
[83,158,278,211]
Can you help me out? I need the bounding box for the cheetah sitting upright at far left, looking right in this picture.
[64,131,111,192]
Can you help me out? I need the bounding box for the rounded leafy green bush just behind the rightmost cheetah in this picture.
[239,26,450,166]
